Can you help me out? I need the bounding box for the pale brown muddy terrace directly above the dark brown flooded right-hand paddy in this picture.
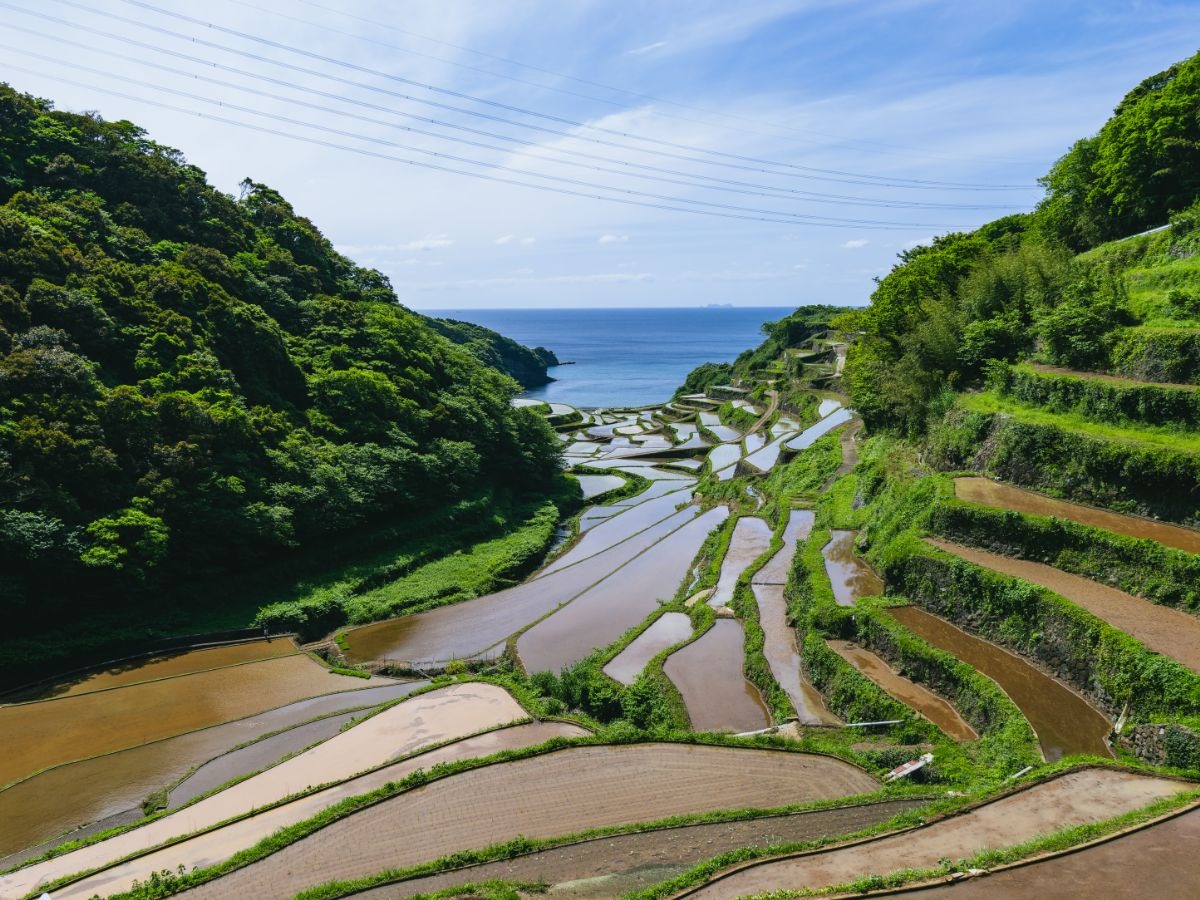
[926,538,1200,672]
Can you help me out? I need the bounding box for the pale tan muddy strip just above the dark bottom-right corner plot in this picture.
[684,769,1188,898]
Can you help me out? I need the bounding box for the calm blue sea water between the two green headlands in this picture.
[426,306,791,407]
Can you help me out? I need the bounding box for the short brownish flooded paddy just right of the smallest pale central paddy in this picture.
[662,619,770,732]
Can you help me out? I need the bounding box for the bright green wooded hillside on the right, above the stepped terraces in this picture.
[838,54,1200,436]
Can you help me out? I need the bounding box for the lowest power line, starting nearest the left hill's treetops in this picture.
[8,64,955,229]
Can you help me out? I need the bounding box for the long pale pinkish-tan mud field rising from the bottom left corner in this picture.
[0,683,526,896]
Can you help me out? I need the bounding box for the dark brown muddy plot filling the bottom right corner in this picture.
[896,808,1200,900]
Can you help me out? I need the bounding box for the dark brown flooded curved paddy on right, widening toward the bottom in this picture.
[888,606,1112,762]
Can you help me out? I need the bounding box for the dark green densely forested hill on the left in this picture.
[0,85,558,628]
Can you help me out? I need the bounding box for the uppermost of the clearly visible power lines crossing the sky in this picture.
[93,0,1028,190]
